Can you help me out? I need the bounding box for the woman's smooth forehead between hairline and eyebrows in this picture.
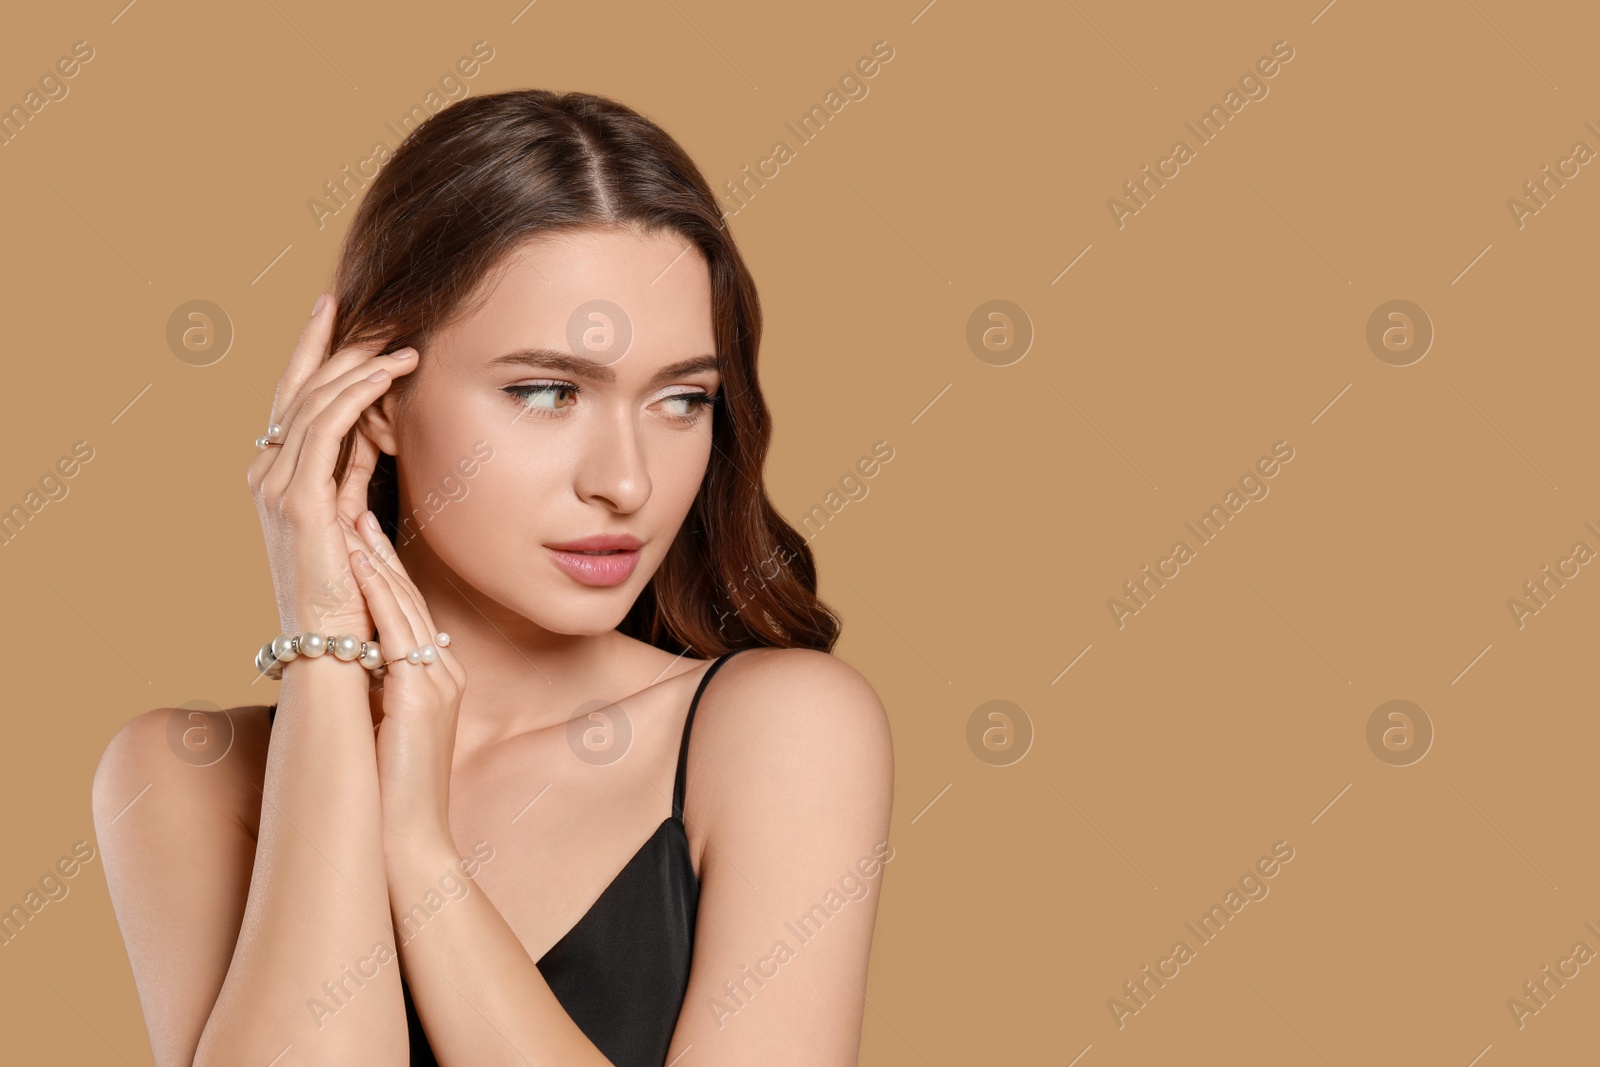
[438,229,715,376]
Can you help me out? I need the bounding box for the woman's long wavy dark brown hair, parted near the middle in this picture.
[330,90,838,657]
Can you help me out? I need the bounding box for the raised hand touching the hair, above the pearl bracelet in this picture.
[245,293,418,640]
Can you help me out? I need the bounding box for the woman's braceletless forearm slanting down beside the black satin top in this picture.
[389,841,610,1067]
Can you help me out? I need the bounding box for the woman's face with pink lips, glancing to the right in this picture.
[368,229,720,633]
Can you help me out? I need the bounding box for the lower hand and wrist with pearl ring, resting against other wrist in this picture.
[350,512,467,859]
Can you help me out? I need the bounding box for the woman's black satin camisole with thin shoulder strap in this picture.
[267,653,734,1067]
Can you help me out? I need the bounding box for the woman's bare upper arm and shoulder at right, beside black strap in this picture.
[669,649,894,1065]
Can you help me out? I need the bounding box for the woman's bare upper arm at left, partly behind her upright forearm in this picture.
[93,709,259,1067]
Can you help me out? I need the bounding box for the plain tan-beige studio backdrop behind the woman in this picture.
[0,0,1600,1067]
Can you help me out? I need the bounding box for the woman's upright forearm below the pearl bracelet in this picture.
[195,656,406,1064]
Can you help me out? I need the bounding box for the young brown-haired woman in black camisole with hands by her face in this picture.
[94,91,893,1067]
